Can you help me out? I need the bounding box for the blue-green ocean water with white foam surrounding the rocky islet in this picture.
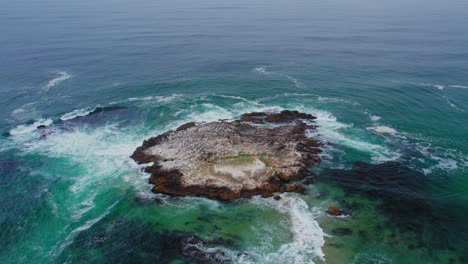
[0,0,468,263]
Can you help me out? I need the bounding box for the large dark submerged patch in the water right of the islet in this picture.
[319,162,468,253]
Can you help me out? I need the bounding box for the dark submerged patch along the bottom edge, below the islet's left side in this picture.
[57,218,234,264]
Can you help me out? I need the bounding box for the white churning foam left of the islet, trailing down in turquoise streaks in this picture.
[11,120,146,256]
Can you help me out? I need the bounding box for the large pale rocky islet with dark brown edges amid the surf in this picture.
[131,110,320,201]
